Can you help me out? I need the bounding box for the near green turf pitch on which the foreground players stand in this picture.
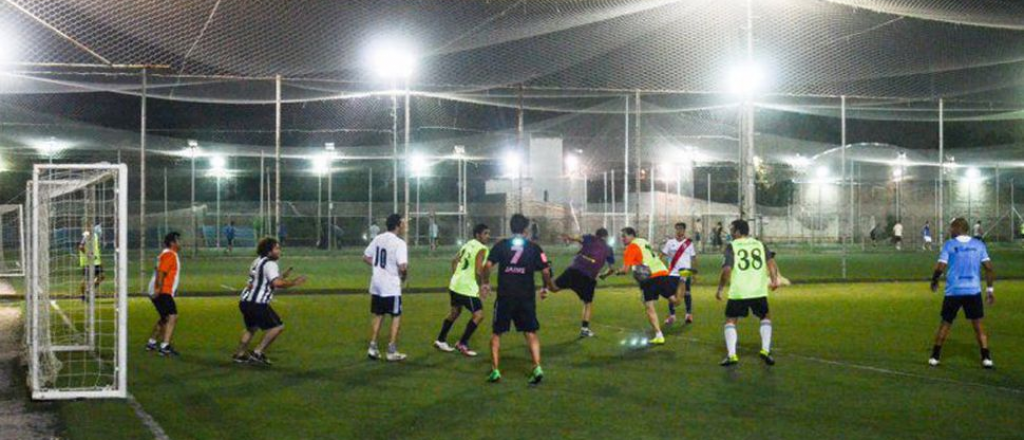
[56,280,1024,440]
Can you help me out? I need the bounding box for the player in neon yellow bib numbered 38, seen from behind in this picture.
[715,220,779,366]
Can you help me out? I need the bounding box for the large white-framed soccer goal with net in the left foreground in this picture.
[27,164,128,399]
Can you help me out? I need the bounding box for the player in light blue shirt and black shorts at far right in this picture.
[928,217,995,368]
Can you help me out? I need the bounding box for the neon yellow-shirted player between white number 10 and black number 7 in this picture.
[434,223,490,357]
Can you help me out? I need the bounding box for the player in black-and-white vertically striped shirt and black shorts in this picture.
[232,237,306,365]
